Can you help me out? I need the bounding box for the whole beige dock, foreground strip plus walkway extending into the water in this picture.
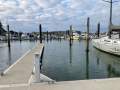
[0,44,120,90]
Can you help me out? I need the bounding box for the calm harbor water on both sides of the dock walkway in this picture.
[0,40,120,81]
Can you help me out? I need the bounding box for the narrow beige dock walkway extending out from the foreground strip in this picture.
[0,43,43,85]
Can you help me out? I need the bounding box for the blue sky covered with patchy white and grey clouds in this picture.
[0,0,120,32]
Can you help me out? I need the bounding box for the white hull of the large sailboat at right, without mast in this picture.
[92,37,120,56]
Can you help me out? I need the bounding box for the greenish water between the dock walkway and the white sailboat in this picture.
[41,40,120,81]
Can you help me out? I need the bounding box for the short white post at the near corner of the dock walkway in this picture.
[35,53,40,82]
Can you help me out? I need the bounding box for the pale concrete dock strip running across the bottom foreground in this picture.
[0,78,120,90]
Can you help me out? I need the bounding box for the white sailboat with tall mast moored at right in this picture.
[92,0,120,56]
